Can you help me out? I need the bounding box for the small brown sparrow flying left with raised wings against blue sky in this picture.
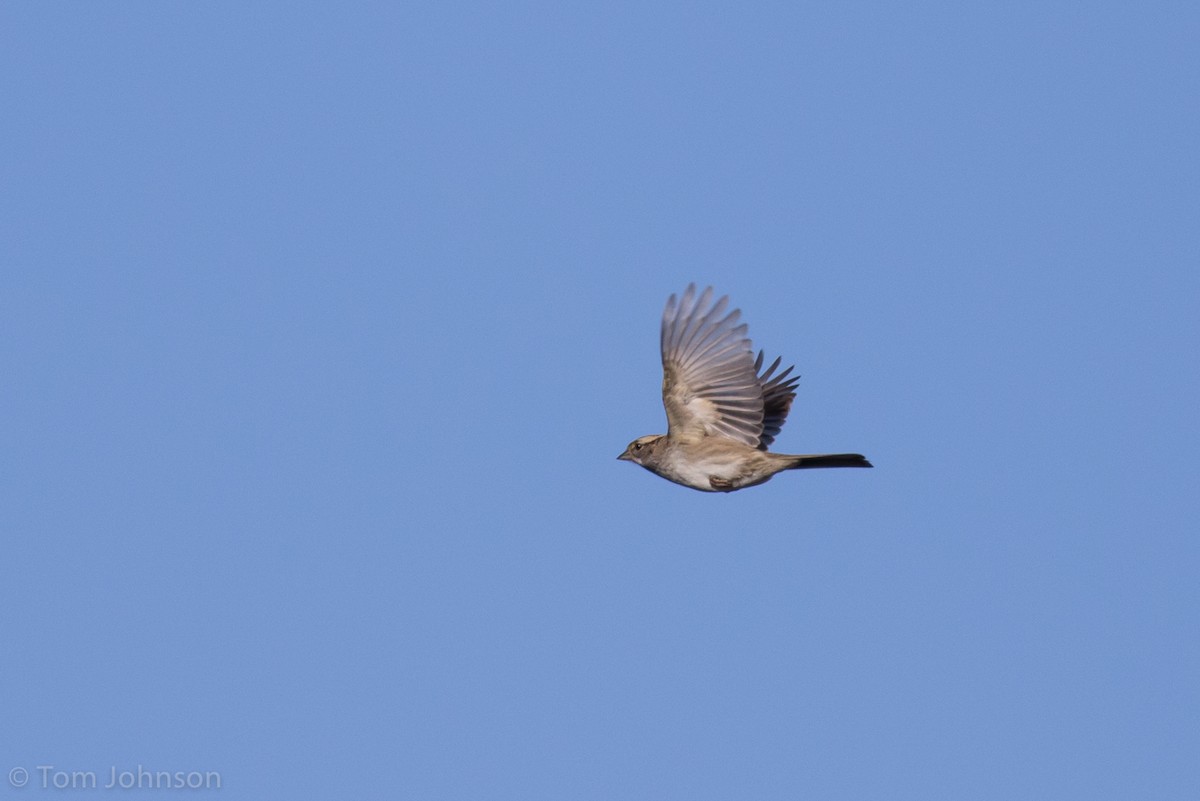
[617,283,874,493]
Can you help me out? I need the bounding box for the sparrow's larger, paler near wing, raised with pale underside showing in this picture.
[661,284,763,447]
